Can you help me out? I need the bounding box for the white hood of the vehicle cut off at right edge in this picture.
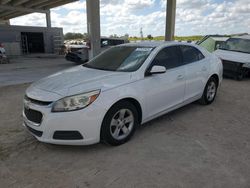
[214,50,250,65]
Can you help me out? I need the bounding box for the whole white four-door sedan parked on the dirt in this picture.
[23,42,222,145]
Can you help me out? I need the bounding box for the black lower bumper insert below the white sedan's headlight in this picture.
[53,131,83,140]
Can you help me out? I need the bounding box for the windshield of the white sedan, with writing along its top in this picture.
[83,46,153,72]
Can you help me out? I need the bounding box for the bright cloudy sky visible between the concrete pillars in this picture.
[10,0,250,36]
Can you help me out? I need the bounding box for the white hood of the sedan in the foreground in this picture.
[26,65,132,101]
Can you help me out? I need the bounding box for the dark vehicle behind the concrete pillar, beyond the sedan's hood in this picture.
[65,37,128,64]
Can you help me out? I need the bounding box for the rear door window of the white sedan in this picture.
[180,46,205,64]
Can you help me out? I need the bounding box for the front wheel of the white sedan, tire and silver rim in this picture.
[101,101,139,146]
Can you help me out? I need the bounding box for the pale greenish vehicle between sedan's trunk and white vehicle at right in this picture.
[197,35,229,53]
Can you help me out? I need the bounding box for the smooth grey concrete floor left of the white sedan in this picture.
[0,56,76,87]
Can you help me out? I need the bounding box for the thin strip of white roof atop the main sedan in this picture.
[121,41,193,48]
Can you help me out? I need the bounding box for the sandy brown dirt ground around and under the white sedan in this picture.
[0,80,250,188]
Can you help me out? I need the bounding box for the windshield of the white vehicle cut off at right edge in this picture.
[220,38,250,53]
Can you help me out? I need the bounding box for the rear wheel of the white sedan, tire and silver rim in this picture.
[199,77,218,105]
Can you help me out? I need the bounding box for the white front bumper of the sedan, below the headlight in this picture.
[23,100,106,145]
